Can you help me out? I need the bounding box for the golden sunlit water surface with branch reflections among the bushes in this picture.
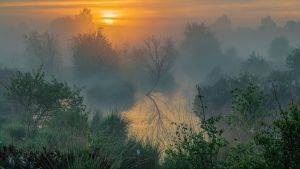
[124,92,199,146]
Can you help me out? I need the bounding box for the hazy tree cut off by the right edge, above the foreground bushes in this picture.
[286,48,300,79]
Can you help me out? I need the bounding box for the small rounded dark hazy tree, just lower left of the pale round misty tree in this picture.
[241,52,271,77]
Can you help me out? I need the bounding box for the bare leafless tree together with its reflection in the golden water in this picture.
[144,37,178,141]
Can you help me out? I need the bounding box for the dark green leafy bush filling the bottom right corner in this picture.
[255,103,300,169]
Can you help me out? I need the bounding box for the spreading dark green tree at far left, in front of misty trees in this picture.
[4,69,85,135]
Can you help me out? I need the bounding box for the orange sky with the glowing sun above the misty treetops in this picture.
[0,0,300,43]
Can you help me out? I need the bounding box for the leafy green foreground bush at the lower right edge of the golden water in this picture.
[164,117,227,169]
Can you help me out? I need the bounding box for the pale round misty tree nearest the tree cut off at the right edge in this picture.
[268,37,291,68]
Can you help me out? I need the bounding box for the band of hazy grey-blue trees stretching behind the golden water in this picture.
[10,9,297,111]
